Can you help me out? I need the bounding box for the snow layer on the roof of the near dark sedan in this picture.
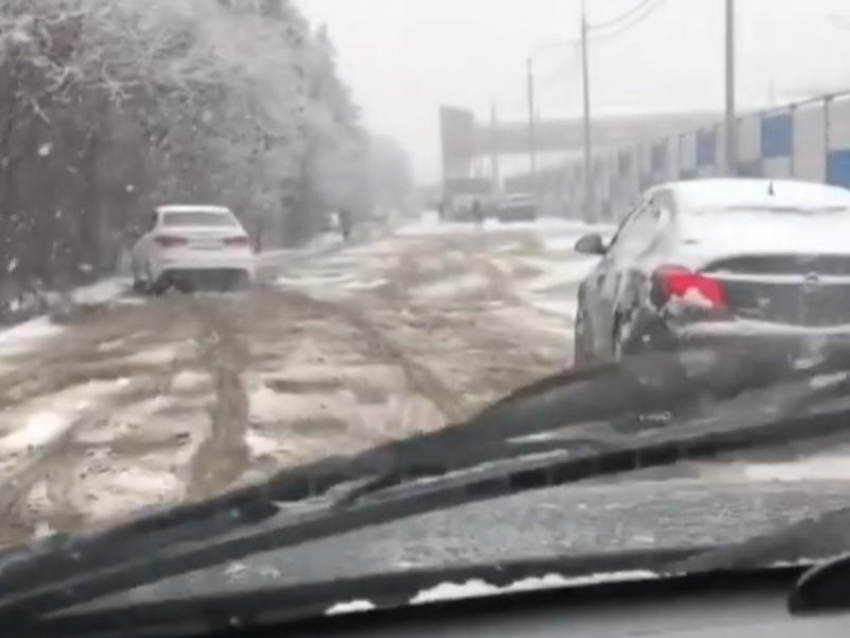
[653,179,850,210]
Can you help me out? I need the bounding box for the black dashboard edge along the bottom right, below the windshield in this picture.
[205,569,850,638]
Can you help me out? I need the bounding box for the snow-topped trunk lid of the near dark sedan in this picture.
[680,211,850,327]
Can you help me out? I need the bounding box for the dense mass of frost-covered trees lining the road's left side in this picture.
[0,0,363,312]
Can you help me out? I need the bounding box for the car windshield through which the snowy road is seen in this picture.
[8,0,850,636]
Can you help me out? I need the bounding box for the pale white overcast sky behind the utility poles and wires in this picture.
[295,0,850,182]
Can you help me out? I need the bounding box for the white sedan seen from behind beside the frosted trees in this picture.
[132,205,254,293]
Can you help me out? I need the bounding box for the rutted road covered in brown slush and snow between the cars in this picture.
[0,221,593,545]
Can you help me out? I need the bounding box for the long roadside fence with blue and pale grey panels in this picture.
[528,87,850,221]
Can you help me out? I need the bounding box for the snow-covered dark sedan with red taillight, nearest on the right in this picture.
[575,179,850,363]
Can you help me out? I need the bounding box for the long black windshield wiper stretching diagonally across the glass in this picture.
[0,348,850,619]
